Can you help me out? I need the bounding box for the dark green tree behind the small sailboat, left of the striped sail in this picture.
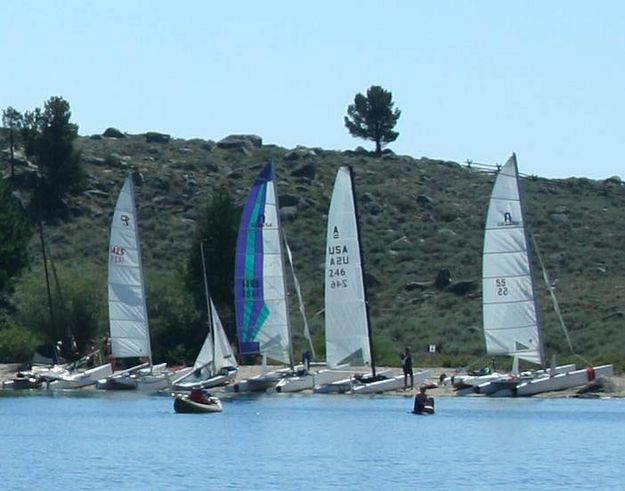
[186,188,241,339]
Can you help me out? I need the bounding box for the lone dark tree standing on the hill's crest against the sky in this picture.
[345,85,401,155]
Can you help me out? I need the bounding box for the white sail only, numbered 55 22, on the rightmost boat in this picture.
[482,155,544,364]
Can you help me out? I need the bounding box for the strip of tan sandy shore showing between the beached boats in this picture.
[0,363,625,398]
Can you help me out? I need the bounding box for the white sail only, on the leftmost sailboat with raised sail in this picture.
[108,176,151,359]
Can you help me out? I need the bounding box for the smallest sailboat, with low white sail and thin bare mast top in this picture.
[173,243,239,391]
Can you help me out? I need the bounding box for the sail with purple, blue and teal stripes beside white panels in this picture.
[234,163,290,363]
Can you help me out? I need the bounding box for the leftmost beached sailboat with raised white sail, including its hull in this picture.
[96,175,180,390]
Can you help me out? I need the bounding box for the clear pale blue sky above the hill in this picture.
[0,0,625,179]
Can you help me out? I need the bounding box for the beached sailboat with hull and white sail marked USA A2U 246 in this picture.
[314,166,429,394]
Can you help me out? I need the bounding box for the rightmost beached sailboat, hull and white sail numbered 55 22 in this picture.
[461,154,612,396]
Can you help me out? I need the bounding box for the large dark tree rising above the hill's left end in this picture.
[22,97,83,209]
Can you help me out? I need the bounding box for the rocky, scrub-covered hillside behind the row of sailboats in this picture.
[2,134,625,364]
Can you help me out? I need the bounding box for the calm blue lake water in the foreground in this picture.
[0,391,625,491]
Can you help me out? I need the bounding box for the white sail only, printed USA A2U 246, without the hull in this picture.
[325,167,371,368]
